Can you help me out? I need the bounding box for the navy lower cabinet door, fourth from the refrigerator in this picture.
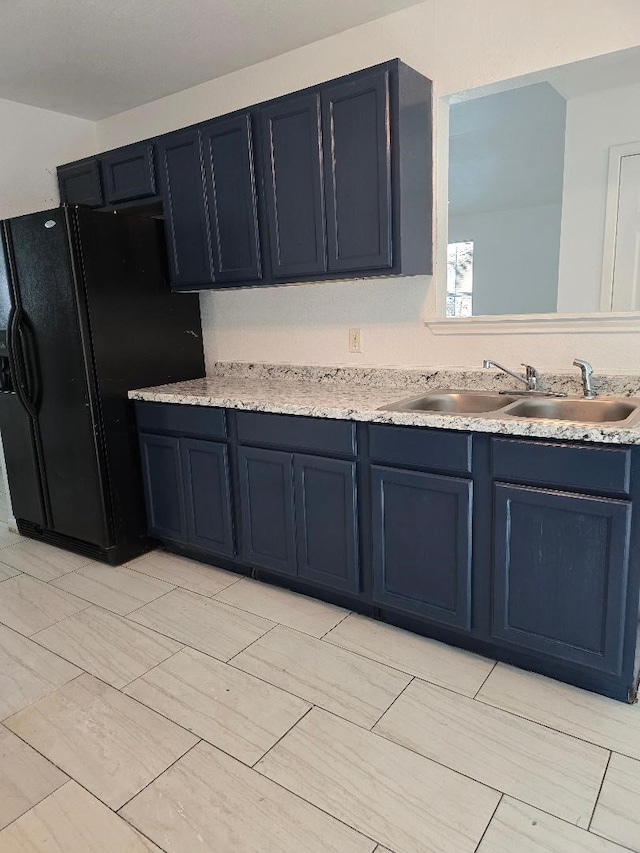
[294,454,360,592]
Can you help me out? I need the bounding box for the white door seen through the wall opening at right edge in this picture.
[611,154,640,311]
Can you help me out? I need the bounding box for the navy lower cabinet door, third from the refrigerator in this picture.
[238,447,297,575]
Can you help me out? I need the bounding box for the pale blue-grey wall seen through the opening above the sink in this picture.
[450,83,566,316]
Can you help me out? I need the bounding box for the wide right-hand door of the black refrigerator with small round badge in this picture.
[8,209,111,547]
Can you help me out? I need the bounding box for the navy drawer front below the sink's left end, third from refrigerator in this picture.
[369,426,471,474]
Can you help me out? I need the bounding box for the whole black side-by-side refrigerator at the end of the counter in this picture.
[0,207,204,565]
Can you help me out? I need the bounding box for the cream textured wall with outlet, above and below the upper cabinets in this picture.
[98,0,640,369]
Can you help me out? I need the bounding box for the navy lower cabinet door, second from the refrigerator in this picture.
[180,438,235,557]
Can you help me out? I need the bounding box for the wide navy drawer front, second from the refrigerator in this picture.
[236,412,355,456]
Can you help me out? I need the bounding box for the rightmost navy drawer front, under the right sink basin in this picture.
[491,438,631,495]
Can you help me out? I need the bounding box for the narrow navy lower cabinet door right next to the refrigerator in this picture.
[140,433,187,542]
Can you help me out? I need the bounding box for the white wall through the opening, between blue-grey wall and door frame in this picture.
[558,83,640,311]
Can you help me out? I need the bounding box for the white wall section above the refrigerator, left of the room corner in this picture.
[0,99,97,219]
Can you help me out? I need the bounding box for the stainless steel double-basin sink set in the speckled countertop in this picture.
[380,390,640,425]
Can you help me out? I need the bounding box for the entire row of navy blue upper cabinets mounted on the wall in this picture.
[58,59,432,290]
